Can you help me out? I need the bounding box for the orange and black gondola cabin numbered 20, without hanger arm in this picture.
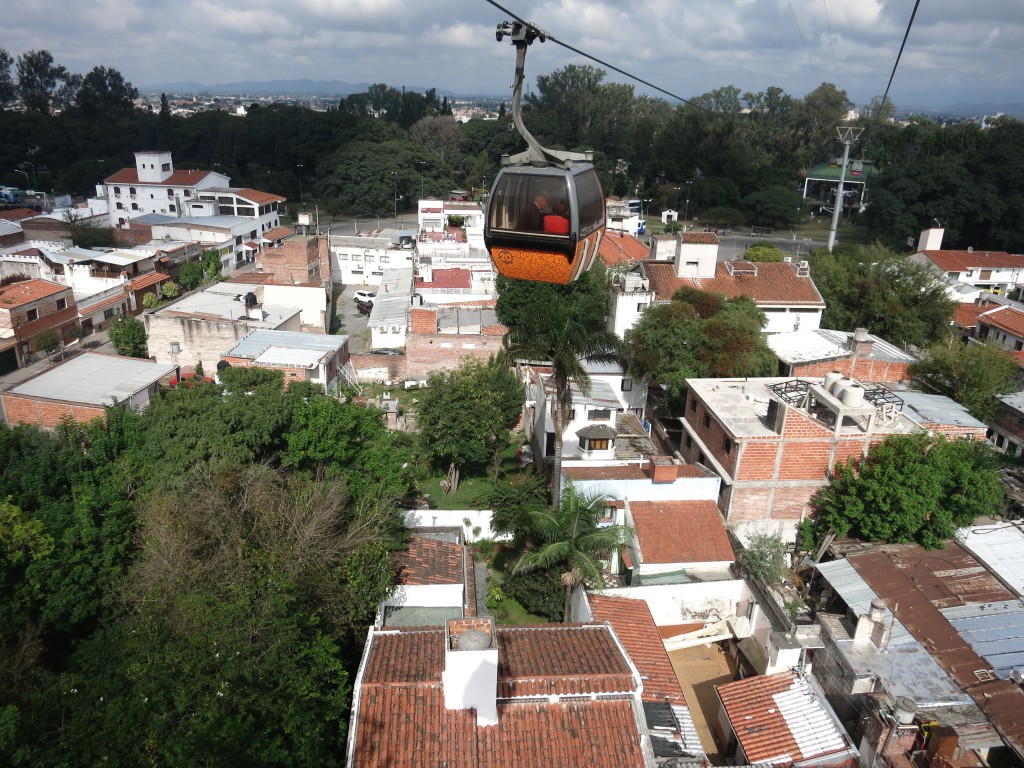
[483,163,604,285]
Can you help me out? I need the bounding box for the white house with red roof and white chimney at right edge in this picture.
[910,227,1024,302]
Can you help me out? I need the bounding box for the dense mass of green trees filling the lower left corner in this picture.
[0,373,412,766]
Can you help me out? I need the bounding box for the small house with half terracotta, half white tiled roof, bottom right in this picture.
[715,672,860,768]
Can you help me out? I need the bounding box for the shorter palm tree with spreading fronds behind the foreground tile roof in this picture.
[512,480,633,623]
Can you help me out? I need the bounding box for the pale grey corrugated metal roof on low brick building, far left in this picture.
[11,352,177,406]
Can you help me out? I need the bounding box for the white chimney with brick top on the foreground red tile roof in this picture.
[441,617,498,726]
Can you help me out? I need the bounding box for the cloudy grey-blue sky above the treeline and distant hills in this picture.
[0,0,1024,109]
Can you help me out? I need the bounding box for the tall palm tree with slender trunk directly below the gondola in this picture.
[505,280,622,510]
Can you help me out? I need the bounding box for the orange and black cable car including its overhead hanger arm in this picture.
[483,22,605,285]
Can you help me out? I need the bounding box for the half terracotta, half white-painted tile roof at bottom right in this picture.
[715,672,847,764]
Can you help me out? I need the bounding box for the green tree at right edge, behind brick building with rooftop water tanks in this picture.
[910,337,1020,422]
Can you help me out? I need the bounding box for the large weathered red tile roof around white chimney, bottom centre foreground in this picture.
[350,625,644,768]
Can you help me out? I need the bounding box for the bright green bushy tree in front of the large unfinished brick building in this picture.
[803,433,1002,549]
